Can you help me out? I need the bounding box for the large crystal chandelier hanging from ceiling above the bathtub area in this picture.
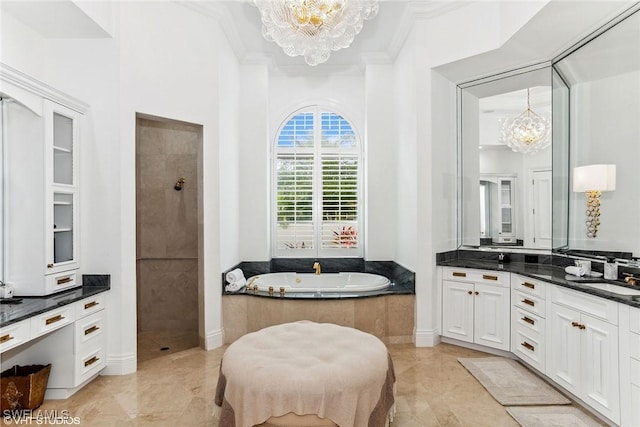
[253,0,378,65]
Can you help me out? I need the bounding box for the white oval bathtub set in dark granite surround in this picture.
[247,273,391,293]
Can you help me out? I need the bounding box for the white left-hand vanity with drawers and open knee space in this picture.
[0,285,109,399]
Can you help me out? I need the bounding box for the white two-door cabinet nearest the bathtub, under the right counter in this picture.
[442,267,510,351]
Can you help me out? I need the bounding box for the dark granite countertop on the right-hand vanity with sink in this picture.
[438,259,640,308]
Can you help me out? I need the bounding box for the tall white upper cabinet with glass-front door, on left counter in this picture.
[5,99,81,296]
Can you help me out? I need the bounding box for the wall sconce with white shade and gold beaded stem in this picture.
[573,165,616,237]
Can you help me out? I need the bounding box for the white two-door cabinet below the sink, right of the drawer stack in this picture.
[547,286,620,424]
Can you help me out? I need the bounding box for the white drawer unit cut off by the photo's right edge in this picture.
[620,304,640,427]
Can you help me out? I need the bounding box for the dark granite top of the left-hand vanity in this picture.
[0,274,111,327]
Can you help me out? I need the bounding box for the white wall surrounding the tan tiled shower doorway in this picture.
[2,2,240,373]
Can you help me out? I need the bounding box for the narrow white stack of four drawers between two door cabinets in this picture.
[511,274,547,373]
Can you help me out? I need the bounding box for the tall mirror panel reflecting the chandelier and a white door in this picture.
[458,64,552,249]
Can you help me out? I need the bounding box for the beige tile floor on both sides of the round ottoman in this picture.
[28,344,600,427]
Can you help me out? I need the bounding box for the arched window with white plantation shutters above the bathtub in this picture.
[272,106,363,257]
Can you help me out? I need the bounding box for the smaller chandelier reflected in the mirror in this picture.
[501,88,551,154]
